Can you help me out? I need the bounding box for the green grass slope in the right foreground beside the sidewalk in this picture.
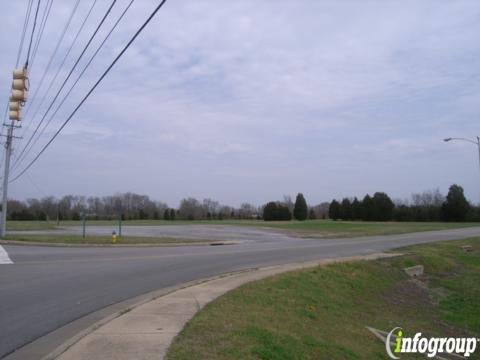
[167,238,480,360]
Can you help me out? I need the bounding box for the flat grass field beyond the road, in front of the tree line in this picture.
[7,220,480,238]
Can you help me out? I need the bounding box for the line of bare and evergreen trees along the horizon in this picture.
[7,185,480,221]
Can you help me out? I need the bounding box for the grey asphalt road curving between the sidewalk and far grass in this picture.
[0,226,480,359]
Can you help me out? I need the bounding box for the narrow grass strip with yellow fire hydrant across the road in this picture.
[5,234,212,245]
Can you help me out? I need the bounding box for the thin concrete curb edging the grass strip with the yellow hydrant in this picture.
[0,240,238,248]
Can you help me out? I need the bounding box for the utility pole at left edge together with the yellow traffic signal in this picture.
[0,68,28,238]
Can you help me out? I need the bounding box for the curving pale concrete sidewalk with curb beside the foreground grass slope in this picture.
[47,253,401,360]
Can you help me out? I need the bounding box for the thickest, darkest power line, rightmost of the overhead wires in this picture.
[10,0,167,182]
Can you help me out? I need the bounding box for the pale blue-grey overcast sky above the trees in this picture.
[0,0,480,206]
